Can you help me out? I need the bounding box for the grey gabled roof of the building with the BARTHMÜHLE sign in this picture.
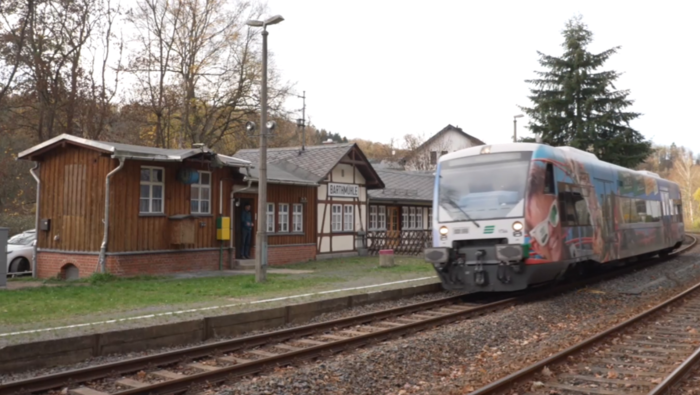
[236,143,384,189]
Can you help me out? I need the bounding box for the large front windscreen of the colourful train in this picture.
[438,151,532,222]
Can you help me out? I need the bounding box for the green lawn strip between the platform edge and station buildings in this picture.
[0,257,434,327]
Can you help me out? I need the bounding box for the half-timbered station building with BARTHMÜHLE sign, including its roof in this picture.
[235,143,384,264]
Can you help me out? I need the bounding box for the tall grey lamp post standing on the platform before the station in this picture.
[246,15,284,283]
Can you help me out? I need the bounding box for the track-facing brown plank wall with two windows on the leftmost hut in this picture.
[108,161,234,252]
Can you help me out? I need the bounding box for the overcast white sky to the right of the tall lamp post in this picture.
[267,0,700,152]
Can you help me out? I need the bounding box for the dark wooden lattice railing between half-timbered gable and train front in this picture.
[367,230,432,255]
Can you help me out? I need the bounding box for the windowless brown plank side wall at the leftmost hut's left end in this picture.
[37,145,116,251]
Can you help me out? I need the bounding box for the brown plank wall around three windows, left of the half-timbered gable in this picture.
[267,184,318,245]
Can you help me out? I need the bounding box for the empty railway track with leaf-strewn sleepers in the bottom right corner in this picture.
[469,238,700,395]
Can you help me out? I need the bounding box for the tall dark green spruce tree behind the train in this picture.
[521,16,652,168]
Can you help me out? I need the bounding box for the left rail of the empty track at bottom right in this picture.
[467,235,700,395]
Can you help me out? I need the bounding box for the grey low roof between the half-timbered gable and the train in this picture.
[368,169,435,203]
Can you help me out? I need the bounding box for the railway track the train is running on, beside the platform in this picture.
[0,238,700,395]
